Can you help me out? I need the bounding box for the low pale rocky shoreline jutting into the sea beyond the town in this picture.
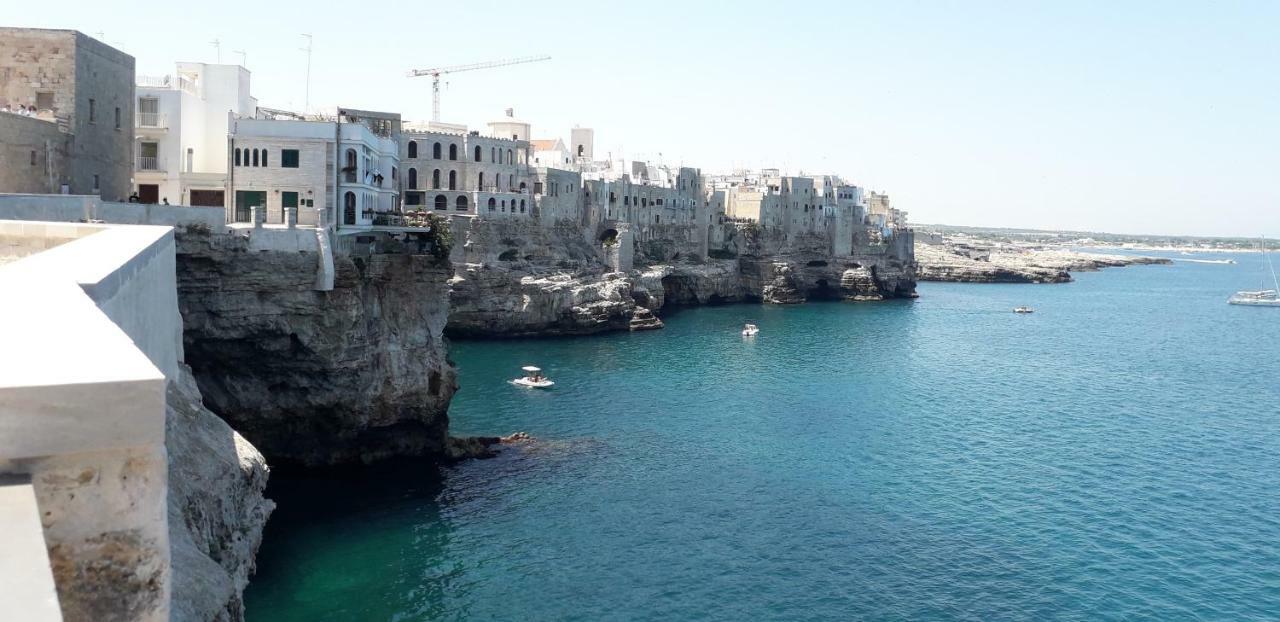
[915,238,1170,283]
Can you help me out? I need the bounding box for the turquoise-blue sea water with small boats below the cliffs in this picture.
[246,255,1280,621]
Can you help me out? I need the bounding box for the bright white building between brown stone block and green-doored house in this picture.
[133,63,257,206]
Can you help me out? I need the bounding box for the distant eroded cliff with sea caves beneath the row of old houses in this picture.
[448,220,915,338]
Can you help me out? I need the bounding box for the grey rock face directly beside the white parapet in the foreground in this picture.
[165,367,275,621]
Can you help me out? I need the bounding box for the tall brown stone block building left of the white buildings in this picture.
[0,28,133,200]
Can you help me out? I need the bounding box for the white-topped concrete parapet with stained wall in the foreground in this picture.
[0,221,182,621]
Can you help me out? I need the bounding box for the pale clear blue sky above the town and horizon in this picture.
[0,0,1280,237]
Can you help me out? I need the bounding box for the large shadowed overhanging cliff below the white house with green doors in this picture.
[178,234,456,465]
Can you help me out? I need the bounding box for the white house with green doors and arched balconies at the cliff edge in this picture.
[227,109,401,229]
